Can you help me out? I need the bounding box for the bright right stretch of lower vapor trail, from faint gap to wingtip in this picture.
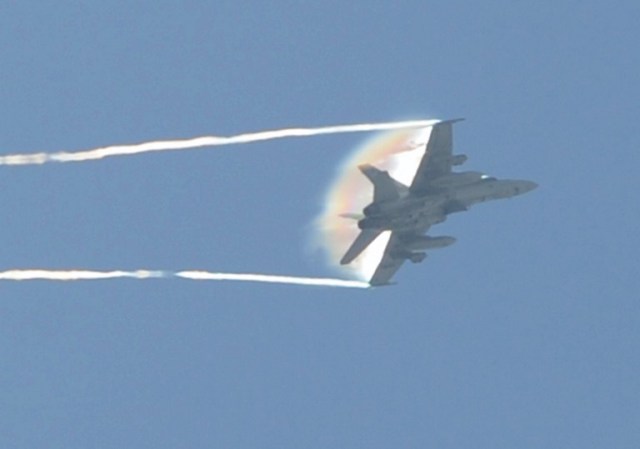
[174,271,370,288]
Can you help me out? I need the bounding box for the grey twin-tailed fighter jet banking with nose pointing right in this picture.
[340,119,537,286]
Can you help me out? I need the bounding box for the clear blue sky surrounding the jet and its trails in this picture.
[0,0,640,449]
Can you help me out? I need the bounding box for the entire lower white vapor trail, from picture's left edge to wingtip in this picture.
[0,270,369,288]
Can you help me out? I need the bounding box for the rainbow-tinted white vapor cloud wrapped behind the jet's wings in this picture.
[314,120,439,281]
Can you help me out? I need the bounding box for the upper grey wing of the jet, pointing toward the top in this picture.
[409,120,458,193]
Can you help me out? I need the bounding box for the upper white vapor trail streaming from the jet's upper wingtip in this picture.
[0,120,439,165]
